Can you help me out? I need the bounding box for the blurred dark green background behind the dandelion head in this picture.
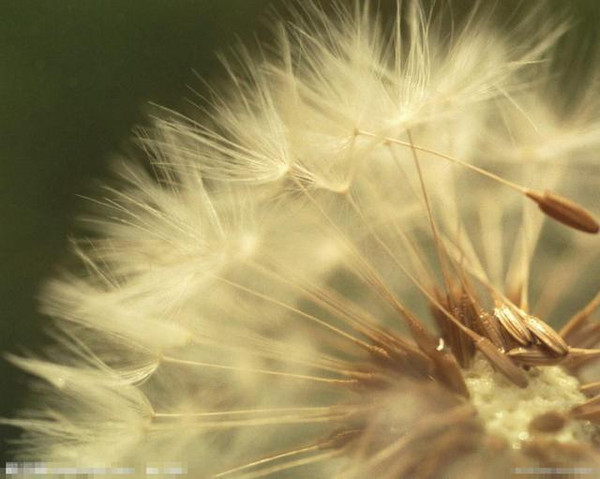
[0,0,600,464]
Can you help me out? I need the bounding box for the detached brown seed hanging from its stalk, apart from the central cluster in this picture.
[525,190,600,234]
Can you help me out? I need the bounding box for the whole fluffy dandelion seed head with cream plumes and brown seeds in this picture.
[5,2,600,479]
